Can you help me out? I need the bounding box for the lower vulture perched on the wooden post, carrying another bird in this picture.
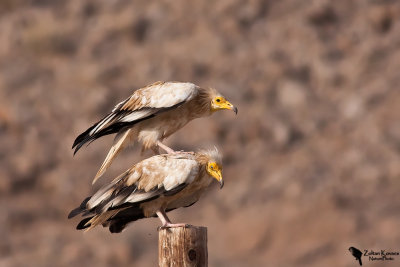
[68,149,224,233]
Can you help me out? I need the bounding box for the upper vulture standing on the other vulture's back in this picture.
[72,82,237,183]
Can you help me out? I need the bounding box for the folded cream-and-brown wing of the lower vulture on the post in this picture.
[87,155,199,213]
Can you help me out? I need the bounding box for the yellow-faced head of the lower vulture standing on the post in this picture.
[198,148,224,188]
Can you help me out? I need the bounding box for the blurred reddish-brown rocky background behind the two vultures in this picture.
[0,0,400,267]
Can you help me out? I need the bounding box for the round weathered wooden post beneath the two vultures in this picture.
[158,225,208,267]
